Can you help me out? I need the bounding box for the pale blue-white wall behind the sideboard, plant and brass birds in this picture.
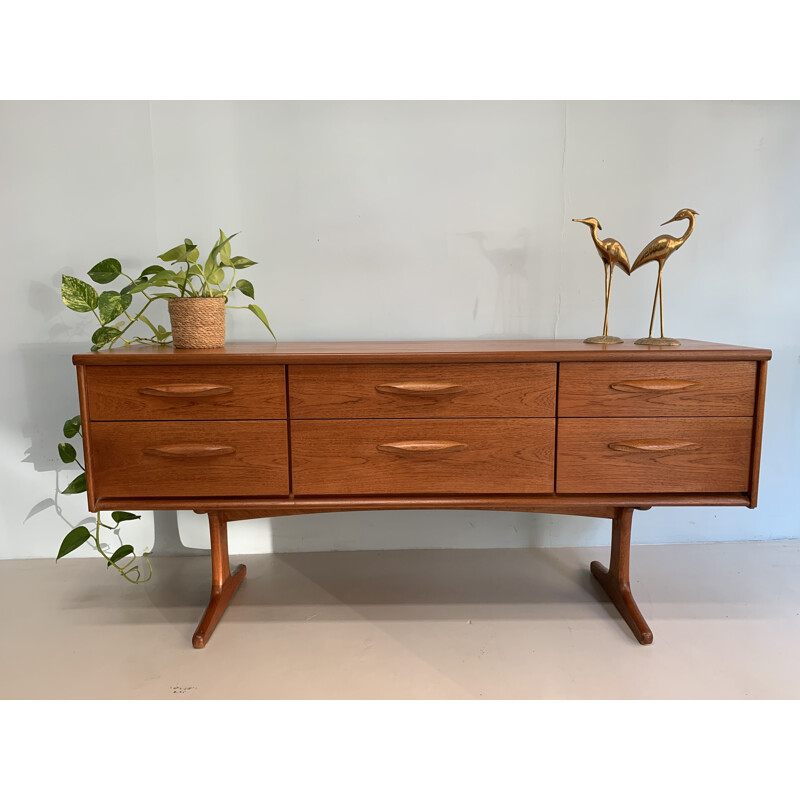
[0,102,800,558]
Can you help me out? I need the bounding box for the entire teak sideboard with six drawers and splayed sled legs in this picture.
[73,340,772,647]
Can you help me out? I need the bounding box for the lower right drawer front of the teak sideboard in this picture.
[556,417,753,494]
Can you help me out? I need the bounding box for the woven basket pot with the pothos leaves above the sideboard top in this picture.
[61,230,275,350]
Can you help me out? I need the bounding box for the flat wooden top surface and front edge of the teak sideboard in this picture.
[72,339,772,366]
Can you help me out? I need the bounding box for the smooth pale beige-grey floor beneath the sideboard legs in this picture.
[0,541,800,699]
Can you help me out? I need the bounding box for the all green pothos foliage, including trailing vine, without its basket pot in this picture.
[56,230,275,583]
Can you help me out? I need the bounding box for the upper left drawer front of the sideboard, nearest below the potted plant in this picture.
[86,366,286,420]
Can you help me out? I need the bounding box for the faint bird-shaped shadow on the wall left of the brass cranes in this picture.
[460,228,531,336]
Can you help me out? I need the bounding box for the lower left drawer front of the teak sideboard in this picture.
[90,421,289,497]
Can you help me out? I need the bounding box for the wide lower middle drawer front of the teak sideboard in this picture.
[291,419,555,495]
